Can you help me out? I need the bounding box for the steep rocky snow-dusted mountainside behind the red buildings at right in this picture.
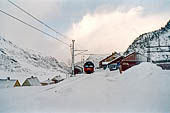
[125,21,170,61]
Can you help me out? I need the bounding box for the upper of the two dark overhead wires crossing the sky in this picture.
[8,0,68,39]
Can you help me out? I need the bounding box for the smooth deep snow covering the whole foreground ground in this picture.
[0,63,170,113]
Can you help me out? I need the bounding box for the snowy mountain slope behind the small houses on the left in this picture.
[0,36,67,82]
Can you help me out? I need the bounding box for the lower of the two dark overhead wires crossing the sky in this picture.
[0,9,70,47]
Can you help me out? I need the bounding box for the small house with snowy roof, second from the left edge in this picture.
[22,76,41,86]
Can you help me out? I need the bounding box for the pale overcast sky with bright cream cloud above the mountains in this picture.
[0,0,170,62]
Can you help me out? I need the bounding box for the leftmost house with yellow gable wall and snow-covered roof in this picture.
[0,77,21,88]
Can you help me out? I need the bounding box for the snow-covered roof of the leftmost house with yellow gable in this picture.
[0,79,17,88]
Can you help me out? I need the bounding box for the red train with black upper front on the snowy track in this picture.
[84,61,94,74]
